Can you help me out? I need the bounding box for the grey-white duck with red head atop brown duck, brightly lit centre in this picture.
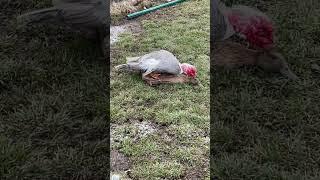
[114,49,197,85]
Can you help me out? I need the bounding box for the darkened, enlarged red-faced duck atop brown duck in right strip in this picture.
[211,0,299,80]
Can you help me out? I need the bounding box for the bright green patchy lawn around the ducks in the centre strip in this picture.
[111,0,210,179]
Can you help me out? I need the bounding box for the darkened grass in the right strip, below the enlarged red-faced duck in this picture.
[210,0,320,179]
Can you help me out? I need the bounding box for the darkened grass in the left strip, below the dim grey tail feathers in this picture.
[0,0,109,179]
